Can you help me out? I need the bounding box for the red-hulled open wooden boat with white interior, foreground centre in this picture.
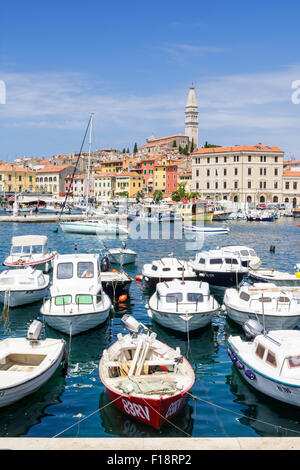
[99,315,195,429]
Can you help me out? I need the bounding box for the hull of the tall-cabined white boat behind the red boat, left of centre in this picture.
[41,307,110,336]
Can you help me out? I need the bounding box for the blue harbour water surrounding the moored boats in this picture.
[0,217,300,438]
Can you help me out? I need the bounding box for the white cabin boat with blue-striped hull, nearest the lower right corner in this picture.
[227,320,300,407]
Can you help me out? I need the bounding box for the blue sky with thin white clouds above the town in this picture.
[0,0,300,161]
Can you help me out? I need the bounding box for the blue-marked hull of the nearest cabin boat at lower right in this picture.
[228,340,300,407]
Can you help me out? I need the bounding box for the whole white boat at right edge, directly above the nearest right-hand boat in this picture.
[223,283,300,330]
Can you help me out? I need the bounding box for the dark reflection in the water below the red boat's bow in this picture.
[99,391,194,437]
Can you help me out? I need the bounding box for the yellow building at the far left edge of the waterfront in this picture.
[0,163,36,193]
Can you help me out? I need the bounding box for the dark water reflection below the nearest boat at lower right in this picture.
[227,366,300,437]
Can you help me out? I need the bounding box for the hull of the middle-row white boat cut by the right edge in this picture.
[226,305,300,330]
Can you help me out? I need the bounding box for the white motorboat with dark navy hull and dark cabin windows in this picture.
[189,248,249,287]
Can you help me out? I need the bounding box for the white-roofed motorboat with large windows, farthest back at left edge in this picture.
[4,235,57,272]
